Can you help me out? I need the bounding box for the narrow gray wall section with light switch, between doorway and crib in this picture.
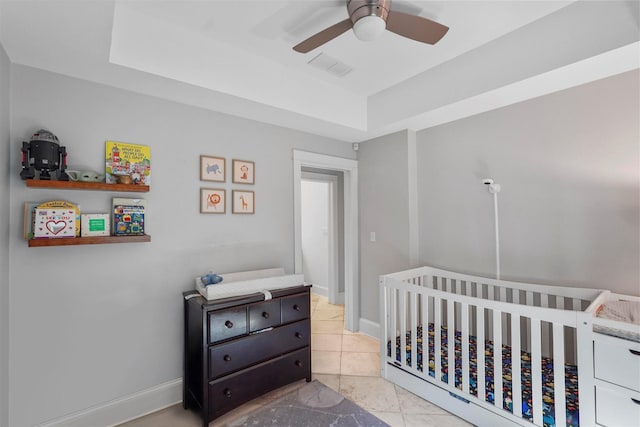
[358,131,409,323]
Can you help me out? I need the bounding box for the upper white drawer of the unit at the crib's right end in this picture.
[593,334,640,392]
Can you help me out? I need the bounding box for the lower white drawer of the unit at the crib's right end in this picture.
[596,381,640,427]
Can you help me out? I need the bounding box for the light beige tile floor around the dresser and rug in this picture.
[121,294,470,427]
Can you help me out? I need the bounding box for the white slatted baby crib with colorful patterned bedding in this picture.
[380,267,606,426]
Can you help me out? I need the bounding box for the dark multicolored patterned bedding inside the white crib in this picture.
[387,324,579,427]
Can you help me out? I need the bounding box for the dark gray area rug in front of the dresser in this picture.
[227,381,390,427]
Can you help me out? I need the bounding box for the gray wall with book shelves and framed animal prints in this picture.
[3,66,354,426]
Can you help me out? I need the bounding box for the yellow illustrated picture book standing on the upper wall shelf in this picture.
[105,141,151,185]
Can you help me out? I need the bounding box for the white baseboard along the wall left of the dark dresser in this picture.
[38,378,182,427]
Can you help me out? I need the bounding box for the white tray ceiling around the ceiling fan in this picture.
[0,0,640,142]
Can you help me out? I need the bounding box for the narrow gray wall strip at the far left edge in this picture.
[0,39,12,427]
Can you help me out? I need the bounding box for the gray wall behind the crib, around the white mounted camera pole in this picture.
[417,70,640,295]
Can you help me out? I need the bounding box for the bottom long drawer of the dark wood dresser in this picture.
[207,347,311,420]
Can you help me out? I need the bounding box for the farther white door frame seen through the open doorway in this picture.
[302,172,344,304]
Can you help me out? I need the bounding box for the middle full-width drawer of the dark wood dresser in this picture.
[209,319,311,379]
